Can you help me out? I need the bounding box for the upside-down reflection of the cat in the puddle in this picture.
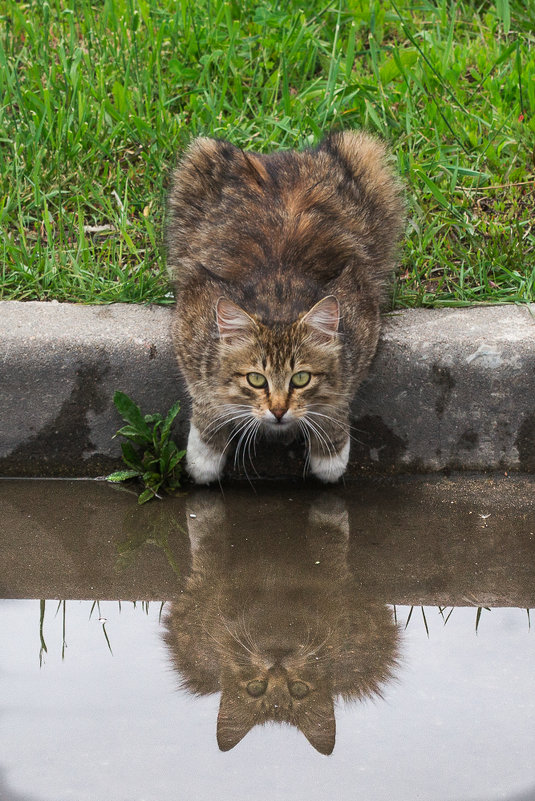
[165,492,398,754]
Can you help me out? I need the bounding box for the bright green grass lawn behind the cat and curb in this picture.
[0,0,535,307]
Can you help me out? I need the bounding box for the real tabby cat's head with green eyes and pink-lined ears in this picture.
[216,295,343,434]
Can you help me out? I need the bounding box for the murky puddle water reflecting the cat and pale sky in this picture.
[0,477,535,801]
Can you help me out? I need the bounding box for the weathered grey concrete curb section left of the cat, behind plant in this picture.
[0,302,186,476]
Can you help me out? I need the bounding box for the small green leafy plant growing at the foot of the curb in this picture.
[106,392,186,503]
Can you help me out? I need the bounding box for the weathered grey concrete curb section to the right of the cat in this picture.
[352,306,535,472]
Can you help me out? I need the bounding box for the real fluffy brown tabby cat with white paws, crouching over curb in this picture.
[167,131,403,483]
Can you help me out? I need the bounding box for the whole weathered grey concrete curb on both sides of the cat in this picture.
[0,301,535,476]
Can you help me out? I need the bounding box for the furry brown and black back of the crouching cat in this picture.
[167,131,402,302]
